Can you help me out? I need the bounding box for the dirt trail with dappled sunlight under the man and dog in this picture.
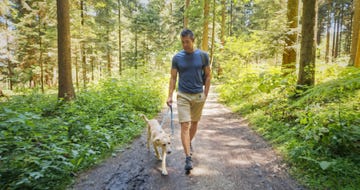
[69,88,304,190]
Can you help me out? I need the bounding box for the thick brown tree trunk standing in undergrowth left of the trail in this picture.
[56,0,75,101]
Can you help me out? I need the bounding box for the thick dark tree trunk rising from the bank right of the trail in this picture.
[297,0,317,87]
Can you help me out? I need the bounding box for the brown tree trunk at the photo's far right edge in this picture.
[349,0,360,65]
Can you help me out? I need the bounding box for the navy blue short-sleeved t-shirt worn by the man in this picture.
[172,49,209,94]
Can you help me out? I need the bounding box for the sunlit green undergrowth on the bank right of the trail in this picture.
[218,66,360,189]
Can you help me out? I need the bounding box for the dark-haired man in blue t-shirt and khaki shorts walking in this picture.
[167,29,210,172]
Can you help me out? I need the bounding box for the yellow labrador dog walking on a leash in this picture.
[141,114,171,175]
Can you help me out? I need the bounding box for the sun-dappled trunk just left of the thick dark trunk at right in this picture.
[282,0,299,76]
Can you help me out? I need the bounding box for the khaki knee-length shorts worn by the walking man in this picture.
[177,92,205,123]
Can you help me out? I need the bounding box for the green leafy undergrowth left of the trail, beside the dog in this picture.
[0,70,166,189]
